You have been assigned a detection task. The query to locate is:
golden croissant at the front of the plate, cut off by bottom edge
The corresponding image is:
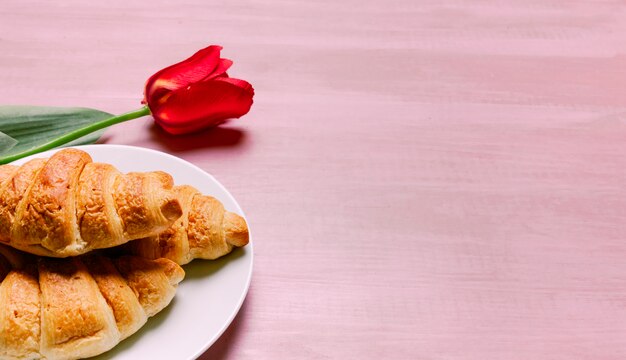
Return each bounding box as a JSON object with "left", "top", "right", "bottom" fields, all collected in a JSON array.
[{"left": 0, "top": 245, "right": 184, "bottom": 360}]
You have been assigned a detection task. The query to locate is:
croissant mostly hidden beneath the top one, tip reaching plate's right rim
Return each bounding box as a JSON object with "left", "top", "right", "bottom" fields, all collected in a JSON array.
[{"left": 124, "top": 185, "right": 249, "bottom": 265}]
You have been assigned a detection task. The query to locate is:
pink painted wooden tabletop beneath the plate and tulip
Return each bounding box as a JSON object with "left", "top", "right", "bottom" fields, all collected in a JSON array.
[{"left": 0, "top": 0, "right": 626, "bottom": 360}]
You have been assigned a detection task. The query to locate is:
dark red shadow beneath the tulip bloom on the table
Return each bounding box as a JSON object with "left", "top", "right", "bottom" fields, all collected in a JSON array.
[{"left": 150, "top": 124, "right": 246, "bottom": 152}]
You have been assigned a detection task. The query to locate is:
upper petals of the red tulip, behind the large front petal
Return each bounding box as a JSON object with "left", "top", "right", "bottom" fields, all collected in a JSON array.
[{"left": 144, "top": 45, "right": 232, "bottom": 105}]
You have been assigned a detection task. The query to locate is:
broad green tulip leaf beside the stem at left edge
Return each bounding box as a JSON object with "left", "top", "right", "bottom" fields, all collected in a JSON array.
[{"left": 0, "top": 106, "right": 113, "bottom": 163}]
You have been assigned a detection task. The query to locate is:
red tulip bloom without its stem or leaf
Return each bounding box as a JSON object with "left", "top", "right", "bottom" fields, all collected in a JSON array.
[{"left": 143, "top": 45, "right": 254, "bottom": 134}]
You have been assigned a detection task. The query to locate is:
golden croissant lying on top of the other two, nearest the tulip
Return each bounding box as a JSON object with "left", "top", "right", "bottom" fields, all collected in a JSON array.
[{"left": 0, "top": 149, "right": 182, "bottom": 257}]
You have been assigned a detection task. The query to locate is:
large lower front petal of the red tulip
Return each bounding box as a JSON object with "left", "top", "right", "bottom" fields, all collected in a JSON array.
[{"left": 152, "top": 77, "right": 254, "bottom": 135}]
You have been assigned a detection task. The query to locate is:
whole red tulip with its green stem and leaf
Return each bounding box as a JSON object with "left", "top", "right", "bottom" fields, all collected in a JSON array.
[{"left": 0, "top": 45, "right": 254, "bottom": 163}]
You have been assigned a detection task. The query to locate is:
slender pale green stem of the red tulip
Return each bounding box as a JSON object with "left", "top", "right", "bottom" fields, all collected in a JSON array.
[{"left": 0, "top": 106, "right": 150, "bottom": 164}]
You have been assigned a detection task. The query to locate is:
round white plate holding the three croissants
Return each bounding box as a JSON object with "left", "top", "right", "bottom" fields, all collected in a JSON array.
[{"left": 14, "top": 145, "right": 253, "bottom": 360}]
